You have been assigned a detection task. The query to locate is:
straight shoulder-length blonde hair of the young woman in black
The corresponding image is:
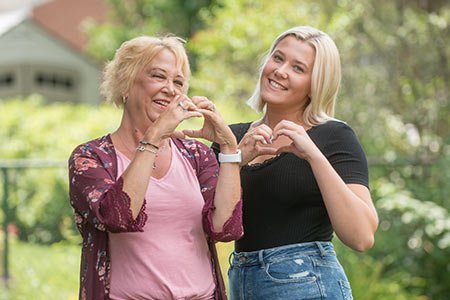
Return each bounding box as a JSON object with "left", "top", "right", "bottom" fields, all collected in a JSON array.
[{"left": 247, "top": 26, "right": 341, "bottom": 126}]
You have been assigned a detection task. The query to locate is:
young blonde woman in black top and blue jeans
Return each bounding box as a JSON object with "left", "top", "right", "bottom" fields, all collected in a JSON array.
[{"left": 213, "top": 26, "right": 378, "bottom": 300}]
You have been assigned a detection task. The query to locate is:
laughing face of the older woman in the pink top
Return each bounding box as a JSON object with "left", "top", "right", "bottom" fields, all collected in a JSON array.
[{"left": 126, "top": 49, "right": 186, "bottom": 126}]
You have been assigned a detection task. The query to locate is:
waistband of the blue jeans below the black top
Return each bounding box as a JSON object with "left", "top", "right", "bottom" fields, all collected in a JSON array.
[{"left": 229, "top": 242, "right": 336, "bottom": 266}]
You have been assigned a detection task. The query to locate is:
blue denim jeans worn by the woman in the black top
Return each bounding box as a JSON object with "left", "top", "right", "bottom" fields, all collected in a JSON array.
[{"left": 228, "top": 242, "right": 353, "bottom": 300}]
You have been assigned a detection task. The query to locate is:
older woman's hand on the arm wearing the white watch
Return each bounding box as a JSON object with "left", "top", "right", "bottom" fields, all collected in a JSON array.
[{"left": 183, "top": 96, "right": 237, "bottom": 149}]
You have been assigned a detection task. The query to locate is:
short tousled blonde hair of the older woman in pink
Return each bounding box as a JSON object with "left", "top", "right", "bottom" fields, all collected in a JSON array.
[{"left": 100, "top": 36, "right": 191, "bottom": 107}]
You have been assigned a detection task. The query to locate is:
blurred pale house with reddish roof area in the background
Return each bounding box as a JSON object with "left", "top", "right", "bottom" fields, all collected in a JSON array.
[{"left": 0, "top": 0, "right": 108, "bottom": 104}]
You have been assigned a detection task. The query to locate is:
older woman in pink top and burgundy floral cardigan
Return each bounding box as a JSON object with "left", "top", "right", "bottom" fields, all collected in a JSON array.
[{"left": 69, "top": 36, "right": 242, "bottom": 300}]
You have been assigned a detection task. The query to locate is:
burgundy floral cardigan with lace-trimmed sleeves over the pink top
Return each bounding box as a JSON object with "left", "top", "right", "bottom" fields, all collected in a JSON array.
[{"left": 69, "top": 135, "right": 243, "bottom": 300}]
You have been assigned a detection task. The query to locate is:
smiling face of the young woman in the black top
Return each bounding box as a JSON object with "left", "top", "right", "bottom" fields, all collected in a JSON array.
[{"left": 261, "top": 36, "right": 315, "bottom": 111}]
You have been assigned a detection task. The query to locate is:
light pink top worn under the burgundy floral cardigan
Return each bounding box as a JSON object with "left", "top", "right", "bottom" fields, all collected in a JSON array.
[{"left": 108, "top": 142, "right": 215, "bottom": 299}]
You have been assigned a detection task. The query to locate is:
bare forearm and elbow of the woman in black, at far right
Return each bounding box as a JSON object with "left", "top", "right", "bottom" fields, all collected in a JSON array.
[{"left": 308, "top": 153, "right": 378, "bottom": 251}]
